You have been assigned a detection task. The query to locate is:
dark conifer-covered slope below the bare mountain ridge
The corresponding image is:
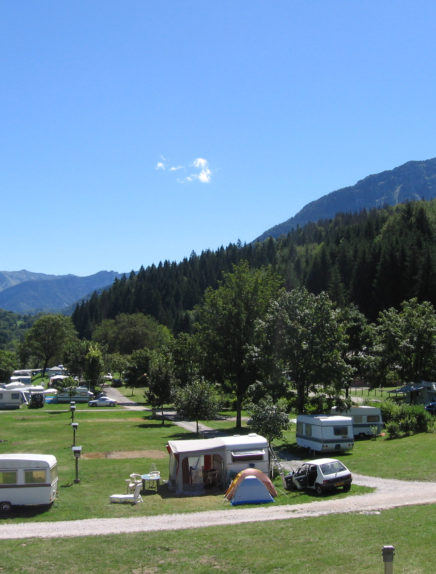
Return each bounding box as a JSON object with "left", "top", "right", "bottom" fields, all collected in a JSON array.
[{"left": 73, "top": 200, "right": 436, "bottom": 338}]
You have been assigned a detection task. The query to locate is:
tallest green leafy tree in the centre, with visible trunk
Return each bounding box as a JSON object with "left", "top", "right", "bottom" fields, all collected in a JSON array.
[{"left": 195, "top": 261, "right": 280, "bottom": 427}]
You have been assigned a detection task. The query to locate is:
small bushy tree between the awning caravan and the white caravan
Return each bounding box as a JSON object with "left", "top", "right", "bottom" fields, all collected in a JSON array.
[{"left": 248, "top": 396, "right": 289, "bottom": 444}]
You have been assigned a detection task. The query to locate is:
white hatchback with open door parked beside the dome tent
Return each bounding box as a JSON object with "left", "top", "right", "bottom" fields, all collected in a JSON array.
[{"left": 285, "top": 458, "right": 353, "bottom": 495}]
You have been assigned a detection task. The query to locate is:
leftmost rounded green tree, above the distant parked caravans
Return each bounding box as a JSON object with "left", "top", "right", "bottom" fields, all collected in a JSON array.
[{"left": 20, "top": 315, "right": 77, "bottom": 376}]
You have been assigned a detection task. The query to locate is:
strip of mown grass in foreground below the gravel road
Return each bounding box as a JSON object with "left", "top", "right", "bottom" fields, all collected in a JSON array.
[{"left": 0, "top": 506, "right": 436, "bottom": 574}]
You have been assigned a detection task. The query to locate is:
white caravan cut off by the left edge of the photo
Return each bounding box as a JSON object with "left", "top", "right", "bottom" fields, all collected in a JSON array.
[{"left": 0, "top": 454, "right": 58, "bottom": 512}]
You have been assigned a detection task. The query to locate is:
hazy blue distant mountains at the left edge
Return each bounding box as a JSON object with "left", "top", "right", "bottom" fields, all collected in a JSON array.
[{"left": 0, "top": 270, "right": 122, "bottom": 314}]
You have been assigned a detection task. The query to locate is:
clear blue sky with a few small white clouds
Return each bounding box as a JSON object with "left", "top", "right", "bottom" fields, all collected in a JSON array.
[{"left": 0, "top": 0, "right": 436, "bottom": 275}]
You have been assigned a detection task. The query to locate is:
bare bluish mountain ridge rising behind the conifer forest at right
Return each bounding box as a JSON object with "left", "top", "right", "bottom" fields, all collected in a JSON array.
[{"left": 255, "top": 158, "right": 436, "bottom": 241}]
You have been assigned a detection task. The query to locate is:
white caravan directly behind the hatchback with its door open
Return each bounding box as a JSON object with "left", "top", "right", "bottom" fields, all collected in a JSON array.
[{"left": 297, "top": 415, "right": 354, "bottom": 452}]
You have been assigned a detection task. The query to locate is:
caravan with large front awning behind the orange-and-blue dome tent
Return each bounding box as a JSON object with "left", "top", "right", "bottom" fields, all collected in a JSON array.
[{"left": 167, "top": 433, "right": 269, "bottom": 494}]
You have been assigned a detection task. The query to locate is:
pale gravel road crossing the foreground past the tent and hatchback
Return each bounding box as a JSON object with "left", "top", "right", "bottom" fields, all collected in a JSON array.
[{"left": 0, "top": 475, "right": 436, "bottom": 540}]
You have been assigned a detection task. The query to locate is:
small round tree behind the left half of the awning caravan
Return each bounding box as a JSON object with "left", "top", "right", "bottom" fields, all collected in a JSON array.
[{"left": 173, "top": 379, "right": 220, "bottom": 434}]
